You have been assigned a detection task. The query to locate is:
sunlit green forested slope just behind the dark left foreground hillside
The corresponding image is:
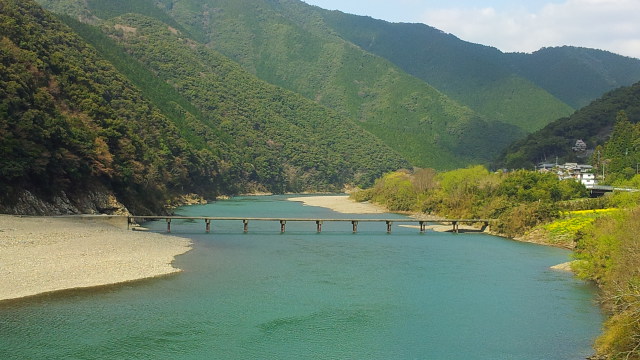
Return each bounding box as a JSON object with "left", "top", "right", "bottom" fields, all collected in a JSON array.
[{"left": 103, "top": 14, "right": 408, "bottom": 191}]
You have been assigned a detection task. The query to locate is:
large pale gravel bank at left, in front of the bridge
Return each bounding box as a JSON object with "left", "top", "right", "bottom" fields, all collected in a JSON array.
[{"left": 0, "top": 215, "right": 191, "bottom": 300}]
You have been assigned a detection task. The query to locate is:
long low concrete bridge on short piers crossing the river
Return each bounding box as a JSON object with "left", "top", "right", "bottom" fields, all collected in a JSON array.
[{"left": 127, "top": 216, "right": 495, "bottom": 234}]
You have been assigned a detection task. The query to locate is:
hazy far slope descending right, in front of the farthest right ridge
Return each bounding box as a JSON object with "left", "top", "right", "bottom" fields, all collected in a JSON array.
[{"left": 318, "top": 11, "right": 573, "bottom": 131}]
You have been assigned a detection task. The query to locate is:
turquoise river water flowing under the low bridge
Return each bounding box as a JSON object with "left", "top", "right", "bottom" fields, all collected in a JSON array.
[{"left": 0, "top": 196, "right": 602, "bottom": 360}]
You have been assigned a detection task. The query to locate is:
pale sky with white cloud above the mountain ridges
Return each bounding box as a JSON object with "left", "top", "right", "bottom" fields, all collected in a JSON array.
[{"left": 303, "top": 0, "right": 640, "bottom": 58}]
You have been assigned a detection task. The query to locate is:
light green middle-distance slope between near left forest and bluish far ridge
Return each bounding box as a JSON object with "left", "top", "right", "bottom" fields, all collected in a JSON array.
[{"left": 40, "top": 0, "right": 524, "bottom": 168}]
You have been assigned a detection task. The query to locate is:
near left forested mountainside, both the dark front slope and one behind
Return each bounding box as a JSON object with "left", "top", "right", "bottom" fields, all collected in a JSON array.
[{"left": 0, "top": 0, "right": 408, "bottom": 212}]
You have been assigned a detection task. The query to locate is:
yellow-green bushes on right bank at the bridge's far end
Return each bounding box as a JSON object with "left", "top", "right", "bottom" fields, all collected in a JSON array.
[{"left": 353, "top": 166, "right": 588, "bottom": 237}]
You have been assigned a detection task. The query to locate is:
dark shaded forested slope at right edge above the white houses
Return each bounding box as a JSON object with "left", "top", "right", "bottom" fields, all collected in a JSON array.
[{"left": 497, "top": 82, "right": 640, "bottom": 168}]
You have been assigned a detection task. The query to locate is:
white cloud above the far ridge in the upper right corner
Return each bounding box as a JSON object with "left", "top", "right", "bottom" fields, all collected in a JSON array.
[{"left": 422, "top": 0, "right": 640, "bottom": 58}]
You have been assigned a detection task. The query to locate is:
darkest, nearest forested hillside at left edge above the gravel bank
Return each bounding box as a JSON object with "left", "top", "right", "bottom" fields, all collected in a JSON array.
[{"left": 0, "top": 0, "right": 228, "bottom": 211}]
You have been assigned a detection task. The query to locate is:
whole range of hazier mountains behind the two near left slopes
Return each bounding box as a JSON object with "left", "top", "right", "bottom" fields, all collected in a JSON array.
[{"left": 33, "top": 0, "right": 640, "bottom": 169}]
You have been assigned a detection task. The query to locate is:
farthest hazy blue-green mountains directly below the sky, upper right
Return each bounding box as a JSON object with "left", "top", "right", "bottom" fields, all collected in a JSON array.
[{"left": 322, "top": 11, "right": 640, "bottom": 126}]
